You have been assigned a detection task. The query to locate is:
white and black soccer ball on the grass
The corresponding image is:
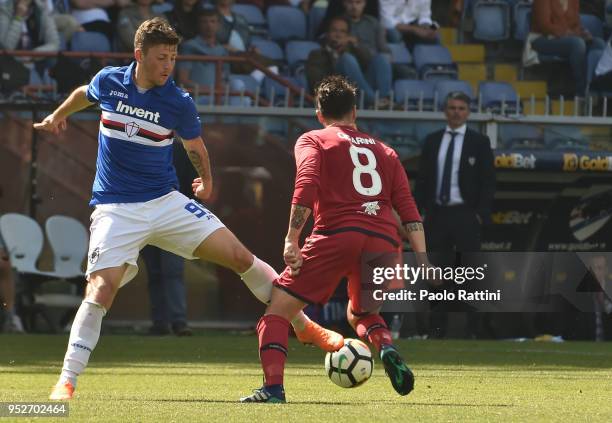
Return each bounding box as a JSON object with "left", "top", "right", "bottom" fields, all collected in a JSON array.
[{"left": 325, "top": 339, "right": 374, "bottom": 388}]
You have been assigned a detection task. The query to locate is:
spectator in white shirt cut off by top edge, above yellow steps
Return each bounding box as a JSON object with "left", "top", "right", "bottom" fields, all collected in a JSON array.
[{"left": 380, "top": 0, "right": 438, "bottom": 49}]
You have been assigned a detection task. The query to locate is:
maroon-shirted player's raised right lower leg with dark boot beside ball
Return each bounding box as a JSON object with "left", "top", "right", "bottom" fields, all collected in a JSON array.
[{"left": 347, "top": 302, "right": 414, "bottom": 395}]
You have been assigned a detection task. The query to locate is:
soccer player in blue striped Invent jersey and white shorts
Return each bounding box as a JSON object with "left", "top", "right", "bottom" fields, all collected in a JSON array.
[{"left": 34, "top": 18, "right": 344, "bottom": 400}]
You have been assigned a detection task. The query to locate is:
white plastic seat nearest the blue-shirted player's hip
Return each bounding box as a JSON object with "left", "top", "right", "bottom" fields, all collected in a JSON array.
[{"left": 45, "top": 215, "right": 88, "bottom": 278}]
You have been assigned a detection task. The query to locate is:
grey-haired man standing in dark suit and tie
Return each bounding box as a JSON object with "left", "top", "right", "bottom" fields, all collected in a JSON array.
[{"left": 414, "top": 92, "right": 495, "bottom": 337}]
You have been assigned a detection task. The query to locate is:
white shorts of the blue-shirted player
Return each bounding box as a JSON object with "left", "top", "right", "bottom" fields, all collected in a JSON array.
[{"left": 86, "top": 191, "right": 225, "bottom": 286}]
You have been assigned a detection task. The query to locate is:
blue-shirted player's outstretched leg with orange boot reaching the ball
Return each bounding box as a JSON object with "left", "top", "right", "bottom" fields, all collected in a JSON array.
[{"left": 194, "top": 228, "right": 344, "bottom": 352}]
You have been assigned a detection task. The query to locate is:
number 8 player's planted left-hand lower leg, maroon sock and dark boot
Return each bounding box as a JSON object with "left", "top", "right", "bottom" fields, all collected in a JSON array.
[{"left": 240, "top": 289, "right": 306, "bottom": 404}]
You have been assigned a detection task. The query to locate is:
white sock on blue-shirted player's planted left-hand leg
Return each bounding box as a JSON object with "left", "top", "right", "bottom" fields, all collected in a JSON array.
[{"left": 60, "top": 300, "right": 106, "bottom": 386}]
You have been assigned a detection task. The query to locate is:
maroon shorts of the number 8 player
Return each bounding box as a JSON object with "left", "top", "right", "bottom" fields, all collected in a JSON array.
[{"left": 274, "top": 231, "right": 401, "bottom": 314}]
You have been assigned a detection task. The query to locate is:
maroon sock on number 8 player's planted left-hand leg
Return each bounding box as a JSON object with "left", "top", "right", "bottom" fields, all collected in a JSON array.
[{"left": 257, "top": 314, "right": 289, "bottom": 386}]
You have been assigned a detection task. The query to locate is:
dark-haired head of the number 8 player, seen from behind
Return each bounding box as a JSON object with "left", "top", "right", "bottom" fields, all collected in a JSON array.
[{"left": 315, "top": 75, "right": 357, "bottom": 119}]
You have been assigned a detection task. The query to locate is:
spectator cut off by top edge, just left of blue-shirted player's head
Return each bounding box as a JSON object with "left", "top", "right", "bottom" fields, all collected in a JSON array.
[{"left": 70, "top": 0, "right": 132, "bottom": 42}]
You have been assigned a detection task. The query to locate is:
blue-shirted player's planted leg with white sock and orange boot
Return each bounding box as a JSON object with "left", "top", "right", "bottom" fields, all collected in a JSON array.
[{"left": 49, "top": 266, "right": 125, "bottom": 401}]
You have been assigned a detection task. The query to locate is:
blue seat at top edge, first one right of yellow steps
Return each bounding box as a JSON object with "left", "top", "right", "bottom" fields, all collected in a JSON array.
[{"left": 472, "top": 0, "right": 510, "bottom": 41}]
